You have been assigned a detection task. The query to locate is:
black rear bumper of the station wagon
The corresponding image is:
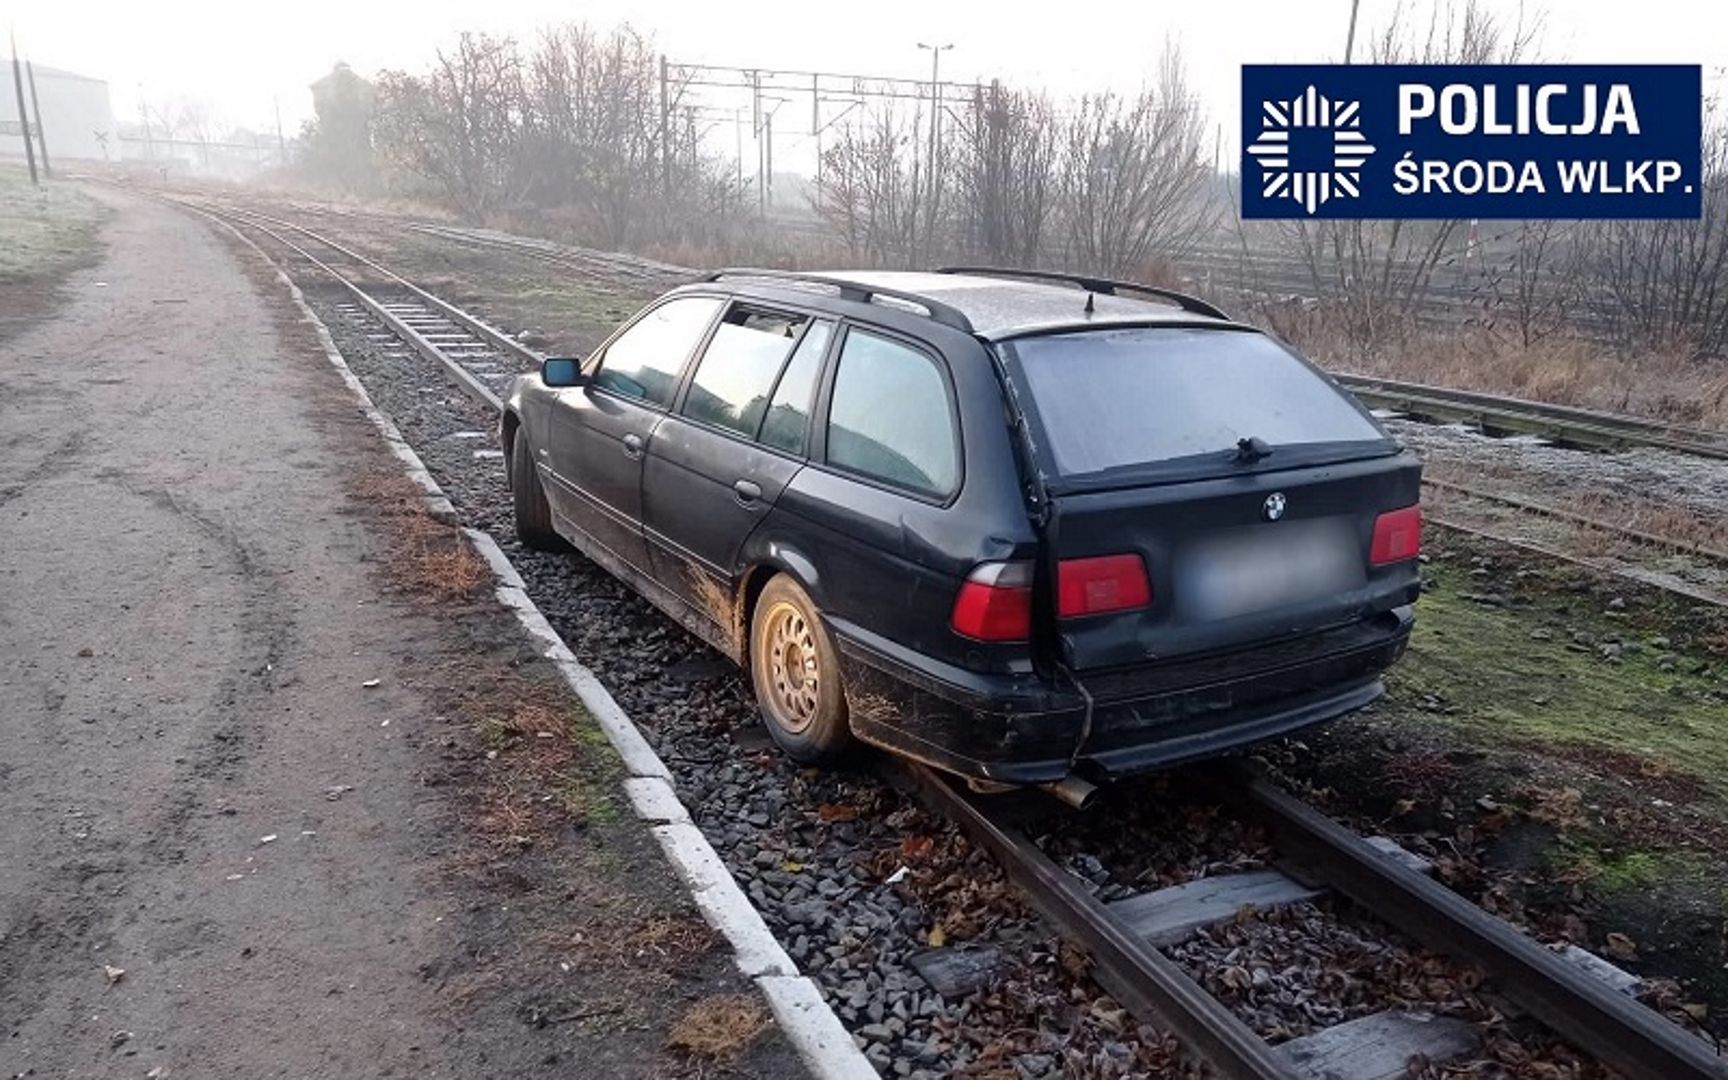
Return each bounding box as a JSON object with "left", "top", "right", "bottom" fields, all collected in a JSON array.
[{"left": 833, "top": 607, "right": 1414, "bottom": 785}]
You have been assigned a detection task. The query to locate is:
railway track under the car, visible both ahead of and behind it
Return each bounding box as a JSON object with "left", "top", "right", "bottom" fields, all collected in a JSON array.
[{"left": 178, "top": 200, "right": 1728, "bottom": 1080}]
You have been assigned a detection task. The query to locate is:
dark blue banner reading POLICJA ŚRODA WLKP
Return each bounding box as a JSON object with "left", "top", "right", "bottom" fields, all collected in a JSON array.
[{"left": 1242, "top": 64, "right": 1704, "bottom": 219}]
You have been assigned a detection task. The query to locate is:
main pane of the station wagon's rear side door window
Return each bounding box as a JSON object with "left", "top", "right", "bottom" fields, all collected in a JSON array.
[{"left": 683, "top": 304, "right": 810, "bottom": 439}]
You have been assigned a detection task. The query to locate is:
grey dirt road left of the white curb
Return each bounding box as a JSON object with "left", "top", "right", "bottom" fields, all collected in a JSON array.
[{"left": 0, "top": 194, "right": 791, "bottom": 1077}]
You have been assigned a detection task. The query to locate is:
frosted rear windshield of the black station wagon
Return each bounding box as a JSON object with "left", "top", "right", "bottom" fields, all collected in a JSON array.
[{"left": 1002, "top": 327, "right": 1386, "bottom": 477}]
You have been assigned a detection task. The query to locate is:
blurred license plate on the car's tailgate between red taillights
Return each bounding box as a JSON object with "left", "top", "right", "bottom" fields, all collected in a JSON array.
[{"left": 1175, "top": 518, "right": 1365, "bottom": 620}]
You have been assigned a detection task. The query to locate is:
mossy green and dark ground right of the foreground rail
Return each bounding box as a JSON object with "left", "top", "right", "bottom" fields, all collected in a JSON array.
[{"left": 1263, "top": 532, "right": 1728, "bottom": 1033}]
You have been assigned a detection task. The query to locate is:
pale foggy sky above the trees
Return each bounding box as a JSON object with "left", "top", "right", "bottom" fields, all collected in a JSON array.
[{"left": 0, "top": 0, "right": 1728, "bottom": 164}]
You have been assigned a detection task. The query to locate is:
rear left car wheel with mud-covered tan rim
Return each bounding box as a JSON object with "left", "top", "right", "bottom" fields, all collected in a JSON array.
[{"left": 750, "top": 574, "right": 854, "bottom": 766}]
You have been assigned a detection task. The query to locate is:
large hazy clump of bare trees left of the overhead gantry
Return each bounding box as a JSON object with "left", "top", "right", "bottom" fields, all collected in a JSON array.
[{"left": 373, "top": 26, "right": 740, "bottom": 247}]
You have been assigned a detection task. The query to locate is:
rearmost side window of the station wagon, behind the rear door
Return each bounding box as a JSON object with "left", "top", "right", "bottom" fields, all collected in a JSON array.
[{"left": 828, "top": 328, "right": 959, "bottom": 496}]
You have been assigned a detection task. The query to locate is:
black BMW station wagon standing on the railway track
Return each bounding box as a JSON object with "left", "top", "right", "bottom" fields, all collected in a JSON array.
[{"left": 499, "top": 270, "right": 1420, "bottom": 800}]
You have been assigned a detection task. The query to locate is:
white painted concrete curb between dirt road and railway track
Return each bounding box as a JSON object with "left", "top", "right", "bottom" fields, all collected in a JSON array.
[{"left": 199, "top": 211, "right": 878, "bottom": 1080}]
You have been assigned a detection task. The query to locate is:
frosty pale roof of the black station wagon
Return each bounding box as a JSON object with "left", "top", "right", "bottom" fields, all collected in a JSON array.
[{"left": 701, "top": 270, "right": 1237, "bottom": 340}]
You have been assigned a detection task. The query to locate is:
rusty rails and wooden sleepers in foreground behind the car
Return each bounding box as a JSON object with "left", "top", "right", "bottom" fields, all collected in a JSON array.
[{"left": 907, "top": 762, "right": 1728, "bottom": 1080}]
